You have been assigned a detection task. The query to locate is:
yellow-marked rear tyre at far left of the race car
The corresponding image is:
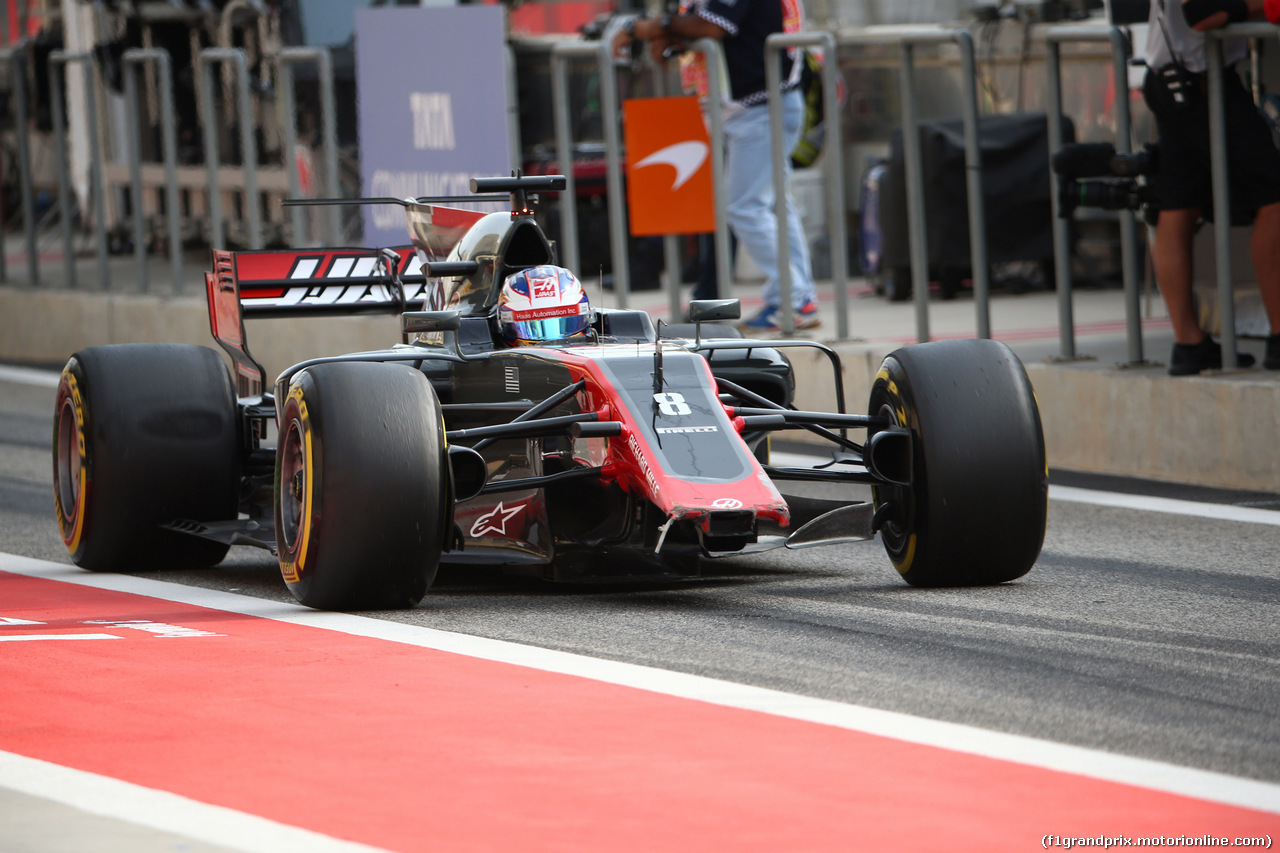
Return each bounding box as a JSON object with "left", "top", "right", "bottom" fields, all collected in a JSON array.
[{"left": 54, "top": 343, "right": 239, "bottom": 571}]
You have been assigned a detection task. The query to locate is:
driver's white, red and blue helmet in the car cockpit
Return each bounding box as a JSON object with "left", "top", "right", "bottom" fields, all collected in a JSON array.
[{"left": 498, "top": 264, "right": 591, "bottom": 347}]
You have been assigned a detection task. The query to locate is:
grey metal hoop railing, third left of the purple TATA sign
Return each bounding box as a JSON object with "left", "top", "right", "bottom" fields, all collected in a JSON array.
[{"left": 123, "top": 47, "right": 182, "bottom": 293}]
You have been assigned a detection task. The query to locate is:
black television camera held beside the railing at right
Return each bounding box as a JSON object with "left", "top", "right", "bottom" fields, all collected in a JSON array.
[{"left": 1053, "top": 142, "right": 1160, "bottom": 219}]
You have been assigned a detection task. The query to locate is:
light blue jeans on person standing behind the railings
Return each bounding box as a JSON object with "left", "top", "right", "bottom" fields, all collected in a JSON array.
[{"left": 724, "top": 88, "right": 814, "bottom": 309}]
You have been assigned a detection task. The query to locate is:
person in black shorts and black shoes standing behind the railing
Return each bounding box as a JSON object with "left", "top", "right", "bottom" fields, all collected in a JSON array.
[{"left": 1143, "top": 0, "right": 1280, "bottom": 377}]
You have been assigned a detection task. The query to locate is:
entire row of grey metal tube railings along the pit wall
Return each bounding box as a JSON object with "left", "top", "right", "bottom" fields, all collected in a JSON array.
[{"left": 0, "top": 20, "right": 1239, "bottom": 365}]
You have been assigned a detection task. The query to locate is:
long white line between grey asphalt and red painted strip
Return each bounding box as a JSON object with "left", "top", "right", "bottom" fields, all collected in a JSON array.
[{"left": 0, "top": 553, "right": 1280, "bottom": 819}]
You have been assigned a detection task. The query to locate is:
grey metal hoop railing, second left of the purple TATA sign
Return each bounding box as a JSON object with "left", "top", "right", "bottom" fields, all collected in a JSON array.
[{"left": 200, "top": 47, "right": 262, "bottom": 248}]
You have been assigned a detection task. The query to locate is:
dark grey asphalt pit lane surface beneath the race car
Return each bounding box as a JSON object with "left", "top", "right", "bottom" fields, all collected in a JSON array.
[{"left": 0, "top": 374, "right": 1280, "bottom": 781}]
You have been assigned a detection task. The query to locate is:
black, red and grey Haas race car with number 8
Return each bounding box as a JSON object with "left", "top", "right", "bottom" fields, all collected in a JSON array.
[{"left": 54, "top": 175, "right": 1048, "bottom": 610}]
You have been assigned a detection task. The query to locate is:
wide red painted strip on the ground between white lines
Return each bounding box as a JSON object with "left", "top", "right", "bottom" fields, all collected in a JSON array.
[{"left": 0, "top": 573, "right": 1276, "bottom": 852}]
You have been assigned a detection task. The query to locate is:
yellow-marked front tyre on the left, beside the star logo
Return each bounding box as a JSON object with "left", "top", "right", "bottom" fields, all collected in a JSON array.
[{"left": 275, "top": 362, "right": 452, "bottom": 610}]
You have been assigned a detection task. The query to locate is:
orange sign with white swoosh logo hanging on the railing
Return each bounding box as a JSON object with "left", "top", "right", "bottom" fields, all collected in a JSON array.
[{"left": 622, "top": 97, "right": 716, "bottom": 237}]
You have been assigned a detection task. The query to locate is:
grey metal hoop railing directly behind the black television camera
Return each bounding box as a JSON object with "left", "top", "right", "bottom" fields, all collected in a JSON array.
[{"left": 1044, "top": 27, "right": 1146, "bottom": 366}]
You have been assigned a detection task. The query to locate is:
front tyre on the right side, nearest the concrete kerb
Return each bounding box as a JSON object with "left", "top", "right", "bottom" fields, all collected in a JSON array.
[{"left": 869, "top": 341, "right": 1048, "bottom": 587}]
